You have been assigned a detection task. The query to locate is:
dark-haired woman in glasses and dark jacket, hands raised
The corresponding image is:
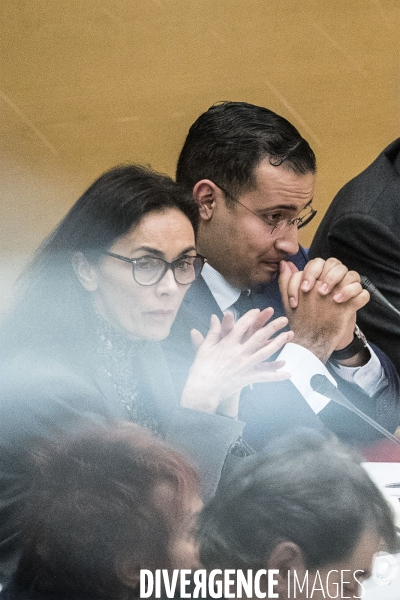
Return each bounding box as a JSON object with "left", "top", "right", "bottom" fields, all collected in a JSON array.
[{"left": 0, "top": 166, "right": 292, "bottom": 582}]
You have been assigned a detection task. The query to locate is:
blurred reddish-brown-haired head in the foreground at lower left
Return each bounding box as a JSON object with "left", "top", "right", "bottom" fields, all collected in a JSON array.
[{"left": 14, "top": 424, "right": 201, "bottom": 600}]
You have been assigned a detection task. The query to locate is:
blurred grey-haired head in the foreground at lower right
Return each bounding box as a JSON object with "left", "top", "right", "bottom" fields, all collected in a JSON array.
[{"left": 199, "top": 431, "right": 396, "bottom": 600}]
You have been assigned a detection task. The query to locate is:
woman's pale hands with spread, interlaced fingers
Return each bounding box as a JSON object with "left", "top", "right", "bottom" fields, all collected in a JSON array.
[{"left": 181, "top": 308, "right": 293, "bottom": 417}]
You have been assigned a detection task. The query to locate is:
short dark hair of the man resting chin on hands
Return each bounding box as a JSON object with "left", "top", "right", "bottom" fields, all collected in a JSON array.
[{"left": 176, "top": 102, "right": 316, "bottom": 200}]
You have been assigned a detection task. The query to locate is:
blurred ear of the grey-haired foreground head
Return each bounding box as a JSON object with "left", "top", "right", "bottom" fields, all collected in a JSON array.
[{"left": 266, "top": 542, "right": 306, "bottom": 599}]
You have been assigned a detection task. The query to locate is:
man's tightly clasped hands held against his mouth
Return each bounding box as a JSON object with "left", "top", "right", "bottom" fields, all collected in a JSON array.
[{"left": 279, "top": 259, "right": 369, "bottom": 366}]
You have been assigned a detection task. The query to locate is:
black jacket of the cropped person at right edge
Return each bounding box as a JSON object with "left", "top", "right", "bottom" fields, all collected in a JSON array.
[{"left": 310, "top": 138, "right": 400, "bottom": 373}]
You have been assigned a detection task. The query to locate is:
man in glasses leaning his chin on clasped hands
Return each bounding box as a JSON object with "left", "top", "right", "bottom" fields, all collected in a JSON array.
[{"left": 166, "top": 102, "right": 399, "bottom": 448}]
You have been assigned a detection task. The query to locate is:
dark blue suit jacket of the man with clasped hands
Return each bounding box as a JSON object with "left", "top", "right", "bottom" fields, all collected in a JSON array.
[{"left": 163, "top": 249, "right": 400, "bottom": 449}]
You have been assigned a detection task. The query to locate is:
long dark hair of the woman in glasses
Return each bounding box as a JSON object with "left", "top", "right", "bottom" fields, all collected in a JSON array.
[{"left": 0, "top": 165, "right": 198, "bottom": 357}]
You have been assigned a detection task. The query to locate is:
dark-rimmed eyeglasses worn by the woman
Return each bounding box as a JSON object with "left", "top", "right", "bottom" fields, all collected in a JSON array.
[{"left": 104, "top": 252, "right": 205, "bottom": 285}]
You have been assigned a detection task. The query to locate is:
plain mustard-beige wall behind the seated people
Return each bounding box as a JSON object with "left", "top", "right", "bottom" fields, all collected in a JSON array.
[{"left": 0, "top": 0, "right": 400, "bottom": 308}]
